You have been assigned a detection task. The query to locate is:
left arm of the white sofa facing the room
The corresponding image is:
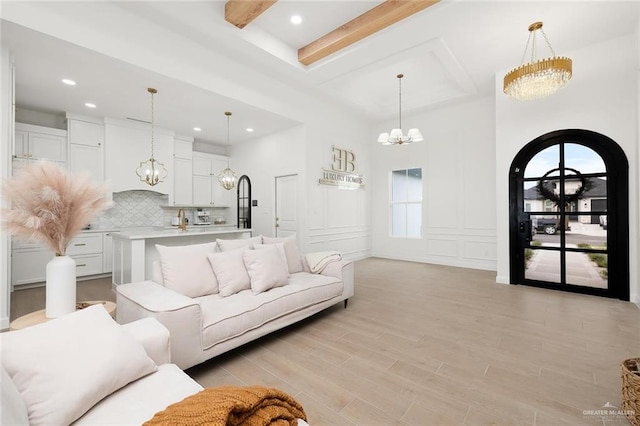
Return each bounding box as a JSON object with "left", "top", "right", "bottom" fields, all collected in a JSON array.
[{"left": 116, "top": 281, "right": 203, "bottom": 369}]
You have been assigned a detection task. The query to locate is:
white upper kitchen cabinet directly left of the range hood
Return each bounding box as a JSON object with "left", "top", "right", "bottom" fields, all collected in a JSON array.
[{"left": 67, "top": 114, "right": 104, "bottom": 182}]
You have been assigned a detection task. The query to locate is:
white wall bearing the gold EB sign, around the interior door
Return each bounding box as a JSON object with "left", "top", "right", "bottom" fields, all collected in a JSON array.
[{"left": 230, "top": 115, "right": 371, "bottom": 259}]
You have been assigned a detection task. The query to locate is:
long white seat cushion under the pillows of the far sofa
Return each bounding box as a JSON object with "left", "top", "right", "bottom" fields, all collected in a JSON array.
[{"left": 197, "top": 272, "right": 344, "bottom": 350}]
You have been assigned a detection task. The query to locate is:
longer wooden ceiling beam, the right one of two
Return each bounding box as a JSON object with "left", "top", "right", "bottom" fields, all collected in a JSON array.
[{"left": 298, "top": 0, "right": 440, "bottom": 65}]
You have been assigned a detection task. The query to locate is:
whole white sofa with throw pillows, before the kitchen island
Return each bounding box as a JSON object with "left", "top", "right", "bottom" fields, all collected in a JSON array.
[{"left": 116, "top": 237, "right": 354, "bottom": 369}]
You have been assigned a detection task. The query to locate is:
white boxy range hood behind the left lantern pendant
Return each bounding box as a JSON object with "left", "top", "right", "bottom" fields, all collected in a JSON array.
[{"left": 104, "top": 119, "right": 175, "bottom": 198}]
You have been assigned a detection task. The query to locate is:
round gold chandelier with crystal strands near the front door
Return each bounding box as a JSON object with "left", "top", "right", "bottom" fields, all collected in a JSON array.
[{"left": 503, "top": 22, "right": 573, "bottom": 100}]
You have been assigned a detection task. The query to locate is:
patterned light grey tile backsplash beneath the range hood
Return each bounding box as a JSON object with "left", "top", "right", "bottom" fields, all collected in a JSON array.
[{"left": 92, "top": 190, "right": 168, "bottom": 228}]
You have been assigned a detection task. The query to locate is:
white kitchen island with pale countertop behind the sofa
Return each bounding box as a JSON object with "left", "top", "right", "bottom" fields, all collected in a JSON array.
[{"left": 111, "top": 226, "right": 251, "bottom": 285}]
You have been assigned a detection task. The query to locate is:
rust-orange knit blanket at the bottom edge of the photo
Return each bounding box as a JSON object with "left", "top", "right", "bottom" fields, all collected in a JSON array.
[{"left": 144, "top": 386, "right": 307, "bottom": 426}]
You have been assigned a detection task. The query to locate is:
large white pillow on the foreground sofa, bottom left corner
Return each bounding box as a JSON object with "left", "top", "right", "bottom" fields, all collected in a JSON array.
[{"left": 0, "top": 305, "right": 156, "bottom": 425}]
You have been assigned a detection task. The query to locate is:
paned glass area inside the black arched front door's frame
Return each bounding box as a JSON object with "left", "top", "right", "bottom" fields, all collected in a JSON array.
[{"left": 520, "top": 142, "right": 608, "bottom": 289}]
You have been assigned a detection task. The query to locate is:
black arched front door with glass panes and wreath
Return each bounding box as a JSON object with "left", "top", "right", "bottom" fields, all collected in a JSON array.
[{"left": 509, "top": 129, "right": 629, "bottom": 300}]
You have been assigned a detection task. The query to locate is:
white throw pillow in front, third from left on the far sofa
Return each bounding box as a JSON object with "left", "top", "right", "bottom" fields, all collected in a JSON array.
[{"left": 242, "top": 244, "right": 289, "bottom": 294}]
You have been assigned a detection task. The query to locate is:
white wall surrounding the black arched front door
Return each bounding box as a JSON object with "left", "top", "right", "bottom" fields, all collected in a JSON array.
[{"left": 495, "top": 35, "right": 640, "bottom": 300}]
